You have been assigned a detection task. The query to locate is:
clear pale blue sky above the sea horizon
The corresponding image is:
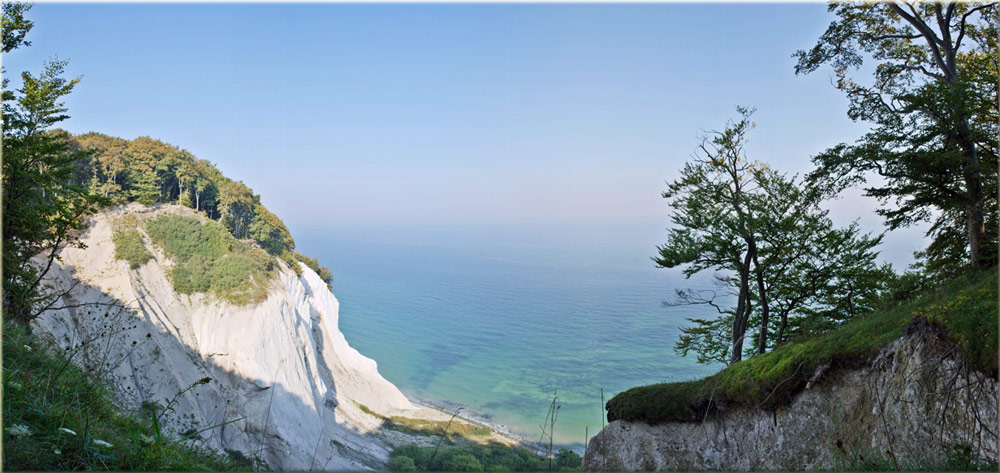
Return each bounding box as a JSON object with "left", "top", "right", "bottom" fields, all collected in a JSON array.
[{"left": 3, "top": 3, "right": 924, "bottom": 258}]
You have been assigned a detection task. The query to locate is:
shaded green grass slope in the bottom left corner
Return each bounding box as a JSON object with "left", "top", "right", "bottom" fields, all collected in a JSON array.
[{"left": 3, "top": 321, "right": 254, "bottom": 471}]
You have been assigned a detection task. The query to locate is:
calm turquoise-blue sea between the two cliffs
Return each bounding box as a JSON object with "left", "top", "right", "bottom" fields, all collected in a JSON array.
[{"left": 293, "top": 225, "right": 718, "bottom": 445}]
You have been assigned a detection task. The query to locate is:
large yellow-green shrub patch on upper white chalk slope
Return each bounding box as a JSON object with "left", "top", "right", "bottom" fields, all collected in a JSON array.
[{"left": 146, "top": 215, "right": 274, "bottom": 305}]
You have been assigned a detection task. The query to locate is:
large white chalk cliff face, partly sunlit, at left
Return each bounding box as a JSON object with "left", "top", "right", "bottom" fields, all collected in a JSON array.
[{"left": 36, "top": 204, "right": 434, "bottom": 470}]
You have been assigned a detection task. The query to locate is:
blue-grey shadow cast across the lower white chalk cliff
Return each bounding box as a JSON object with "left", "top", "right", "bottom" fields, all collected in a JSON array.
[{"left": 34, "top": 266, "right": 402, "bottom": 470}]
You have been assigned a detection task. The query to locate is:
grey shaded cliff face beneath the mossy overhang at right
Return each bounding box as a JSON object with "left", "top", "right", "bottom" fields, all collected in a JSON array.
[{"left": 583, "top": 321, "right": 998, "bottom": 471}]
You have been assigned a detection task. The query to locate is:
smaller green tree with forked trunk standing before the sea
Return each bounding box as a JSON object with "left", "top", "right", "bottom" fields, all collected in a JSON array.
[{"left": 654, "top": 109, "right": 892, "bottom": 363}]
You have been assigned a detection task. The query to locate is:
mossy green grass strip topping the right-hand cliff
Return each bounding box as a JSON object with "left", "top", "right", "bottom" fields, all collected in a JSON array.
[{"left": 607, "top": 269, "right": 998, "bottom": 423}]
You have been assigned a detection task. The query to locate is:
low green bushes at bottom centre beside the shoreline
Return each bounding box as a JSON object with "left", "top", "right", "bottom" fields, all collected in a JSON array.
[{"left": 389, "top": 443, "right": 583, "bottom": 471}]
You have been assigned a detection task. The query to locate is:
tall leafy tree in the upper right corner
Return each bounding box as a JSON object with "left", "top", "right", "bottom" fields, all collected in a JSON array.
[{"left": 795, "top": 2, "right": 998, "bottom": 267}]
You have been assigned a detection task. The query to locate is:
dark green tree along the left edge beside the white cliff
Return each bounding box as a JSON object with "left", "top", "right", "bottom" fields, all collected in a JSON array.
[{"left": 2, "top": 19, "right": 104, "bottom": 322}]
